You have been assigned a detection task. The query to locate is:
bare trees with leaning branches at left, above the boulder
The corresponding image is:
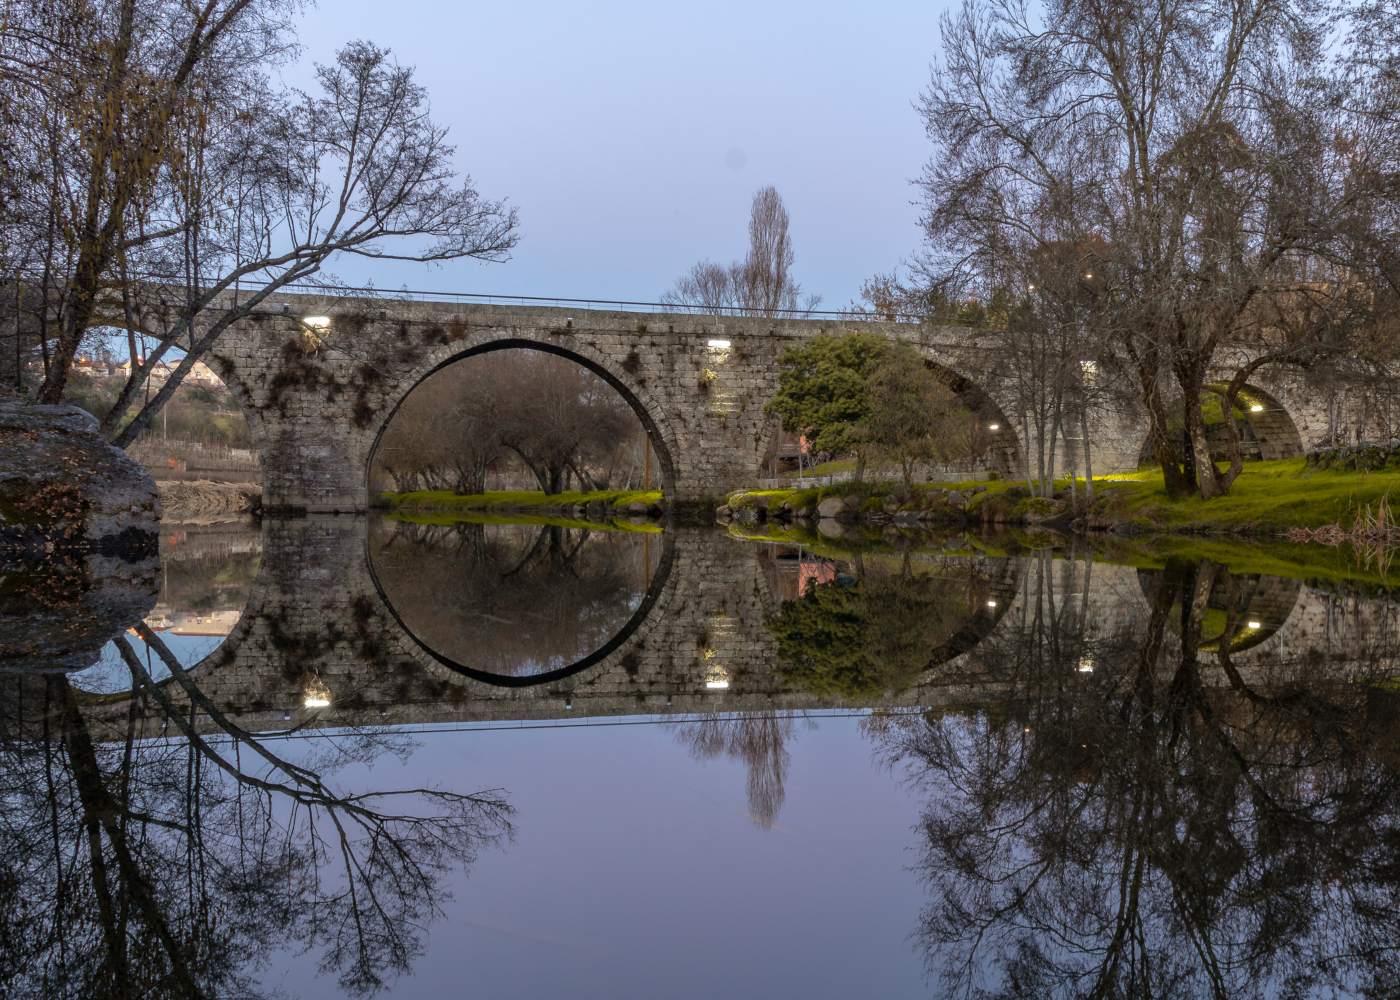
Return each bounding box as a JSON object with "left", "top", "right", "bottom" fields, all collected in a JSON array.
[{"left": 0, "top": 0, "right": 517, "bottom": 444}]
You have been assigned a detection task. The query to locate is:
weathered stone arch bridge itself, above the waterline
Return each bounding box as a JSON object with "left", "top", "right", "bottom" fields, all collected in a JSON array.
[{"left": 117, "top": 294, "right": 1377, "bottom": 511}]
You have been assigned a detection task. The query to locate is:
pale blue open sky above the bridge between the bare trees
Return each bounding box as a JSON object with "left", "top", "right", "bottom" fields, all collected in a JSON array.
[{"left": 289, "top": 0, "right": 948, "bottom": 308}]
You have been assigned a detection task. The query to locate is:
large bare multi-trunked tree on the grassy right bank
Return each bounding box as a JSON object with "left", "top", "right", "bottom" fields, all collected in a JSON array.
[{"left": 920, "top": 0, "right": 1397, "bottom": 496}]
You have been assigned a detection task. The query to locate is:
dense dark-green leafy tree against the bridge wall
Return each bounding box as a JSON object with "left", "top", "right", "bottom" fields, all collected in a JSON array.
[{"left": 766, "top": 333, "right": 889, "bottom": 479}]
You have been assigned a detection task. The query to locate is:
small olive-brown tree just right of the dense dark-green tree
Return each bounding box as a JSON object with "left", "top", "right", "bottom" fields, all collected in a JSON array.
[{"left": 864, "top": 343, "right": 973, "bottom": 490}]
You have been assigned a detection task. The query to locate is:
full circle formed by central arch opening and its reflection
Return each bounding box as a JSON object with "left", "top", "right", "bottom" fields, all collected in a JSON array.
[{"left": 367, "top": 339, "right": 675, "bottom": 686}]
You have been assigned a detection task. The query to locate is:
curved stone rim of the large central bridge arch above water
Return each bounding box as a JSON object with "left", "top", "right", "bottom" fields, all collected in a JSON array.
[{"left": 364, "top": 331, "right": 679, "bottom": 496}]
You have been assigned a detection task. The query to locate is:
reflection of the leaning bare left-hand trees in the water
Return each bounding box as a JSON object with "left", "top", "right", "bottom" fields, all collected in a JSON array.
[{"left": 0, "top": 627, "right": 510, "bottom": 997}]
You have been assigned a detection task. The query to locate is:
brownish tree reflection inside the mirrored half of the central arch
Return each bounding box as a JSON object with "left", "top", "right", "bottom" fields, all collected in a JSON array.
[{"left": 374, "top": 522, "right": 659, "bottom": 675}]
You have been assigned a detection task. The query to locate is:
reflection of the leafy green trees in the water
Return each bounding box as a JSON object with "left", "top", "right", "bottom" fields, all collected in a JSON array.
[{"left": 767, "top": 553, "right": 991, "bottom": 700}]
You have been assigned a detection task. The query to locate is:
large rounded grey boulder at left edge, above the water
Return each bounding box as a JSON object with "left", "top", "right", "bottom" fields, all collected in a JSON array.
[{"left": 0, "top": 395, "right": 161, "bottom": 555}]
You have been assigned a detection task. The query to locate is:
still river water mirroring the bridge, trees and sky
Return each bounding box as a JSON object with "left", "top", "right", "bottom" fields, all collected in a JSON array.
[{"left": 0, "top": 518, "right": 1400, "bottom": 997}]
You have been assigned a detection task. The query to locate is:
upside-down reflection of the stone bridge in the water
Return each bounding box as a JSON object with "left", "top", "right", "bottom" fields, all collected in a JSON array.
[{"left": 79, "top": 517, "right": 1400, "bottom": 730}]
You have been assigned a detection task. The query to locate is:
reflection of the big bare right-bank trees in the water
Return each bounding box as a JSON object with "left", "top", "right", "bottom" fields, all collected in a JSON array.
[{"left": 869, "top": 563, "right": 1400, "bottom": 997}]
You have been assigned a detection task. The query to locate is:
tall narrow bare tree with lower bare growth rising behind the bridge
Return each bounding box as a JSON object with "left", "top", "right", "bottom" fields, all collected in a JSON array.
[{"left": 661, "top": 185, "right": 820, "bottom": 317}]
